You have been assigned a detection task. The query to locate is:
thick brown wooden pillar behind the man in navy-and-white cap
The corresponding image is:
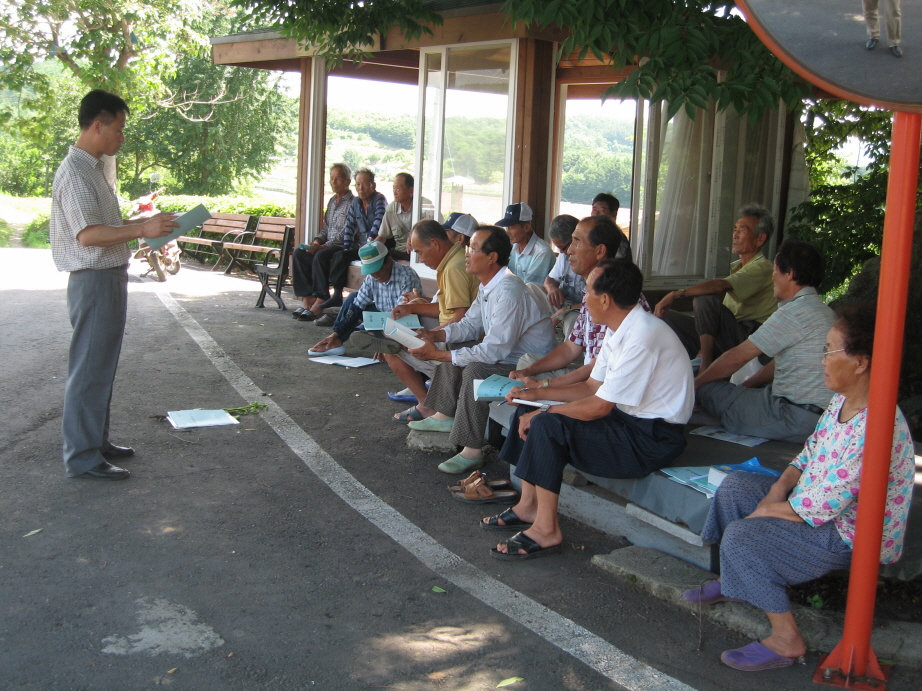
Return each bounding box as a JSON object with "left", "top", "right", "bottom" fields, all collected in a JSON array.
[{"left": 511, "top": 38, "right": 556, "bottom": 237}]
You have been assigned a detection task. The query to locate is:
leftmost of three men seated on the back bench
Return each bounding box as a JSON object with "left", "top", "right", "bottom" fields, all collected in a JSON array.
[{"left": 291, "top": 163, "right": 355, "bottom": 320}]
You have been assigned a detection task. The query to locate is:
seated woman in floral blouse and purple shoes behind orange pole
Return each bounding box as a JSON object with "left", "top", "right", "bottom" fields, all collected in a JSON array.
[{"left": 683, "top": 303, "right": 915, "bottom": 672}]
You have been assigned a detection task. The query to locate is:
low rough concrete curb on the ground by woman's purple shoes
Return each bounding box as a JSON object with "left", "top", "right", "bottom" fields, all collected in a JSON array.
[{"left": 592, "top": 546, "right": 922, "bottom": 669}]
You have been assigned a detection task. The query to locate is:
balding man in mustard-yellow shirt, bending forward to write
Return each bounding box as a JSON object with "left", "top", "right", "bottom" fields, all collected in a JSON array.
[{"left": 355, "top": 220, "right": 480, "bottom": 422}]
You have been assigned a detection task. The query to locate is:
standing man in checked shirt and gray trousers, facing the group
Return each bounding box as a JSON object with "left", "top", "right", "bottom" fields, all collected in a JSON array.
[{"left": 51, "top": 89, "right": 177, "bottom": 480}]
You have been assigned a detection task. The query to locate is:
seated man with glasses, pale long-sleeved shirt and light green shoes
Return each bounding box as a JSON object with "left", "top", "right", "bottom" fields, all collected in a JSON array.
[{"left": 410, "top": 226, "right": 554, "bottom": 473}]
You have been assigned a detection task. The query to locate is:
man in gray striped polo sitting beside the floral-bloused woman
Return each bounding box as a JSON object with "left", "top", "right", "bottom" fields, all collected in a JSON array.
[{"left": 695, "top": 240, "right": 834, "bottom": 444}]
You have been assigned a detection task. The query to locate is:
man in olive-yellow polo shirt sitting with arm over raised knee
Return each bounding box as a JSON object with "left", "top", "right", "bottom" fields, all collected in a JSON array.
[{"left": 654, "top": 204, "right": 778, "bottom": 372}]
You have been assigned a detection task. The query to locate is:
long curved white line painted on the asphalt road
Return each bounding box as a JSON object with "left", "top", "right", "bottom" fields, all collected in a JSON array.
[{"left": 155, "top": 286, "right": 695, "bottom": 691}]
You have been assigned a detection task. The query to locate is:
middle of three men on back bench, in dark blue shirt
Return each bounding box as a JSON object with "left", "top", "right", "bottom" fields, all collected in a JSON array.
[{"left": 298, "top": 168, "right": 387, "bottom": 321}]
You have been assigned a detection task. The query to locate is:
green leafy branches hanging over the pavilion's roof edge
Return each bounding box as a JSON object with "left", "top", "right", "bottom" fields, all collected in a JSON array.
[{"left": 241, "top": 0, "right": 809, "bottom": 121}]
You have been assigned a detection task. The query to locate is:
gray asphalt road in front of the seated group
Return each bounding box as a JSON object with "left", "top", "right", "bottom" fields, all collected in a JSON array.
[{"left": 0, "top": 249, "right": 922, "bottom": 691}]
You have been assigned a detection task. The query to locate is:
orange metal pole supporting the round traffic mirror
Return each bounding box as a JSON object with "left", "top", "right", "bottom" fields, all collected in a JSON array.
[{"left": 820, "top": 113, "right": 922, "bottom": 687}]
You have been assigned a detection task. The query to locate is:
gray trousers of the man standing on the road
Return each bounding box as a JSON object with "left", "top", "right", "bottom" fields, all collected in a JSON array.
[{"left": 61, "top": 266, "right": 128, "bottom": 477}]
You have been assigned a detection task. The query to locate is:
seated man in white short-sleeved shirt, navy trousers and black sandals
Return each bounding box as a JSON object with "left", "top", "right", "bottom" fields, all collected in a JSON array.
[{"left": 481, "top": 261, "right": 694, "bottom": 560}]
